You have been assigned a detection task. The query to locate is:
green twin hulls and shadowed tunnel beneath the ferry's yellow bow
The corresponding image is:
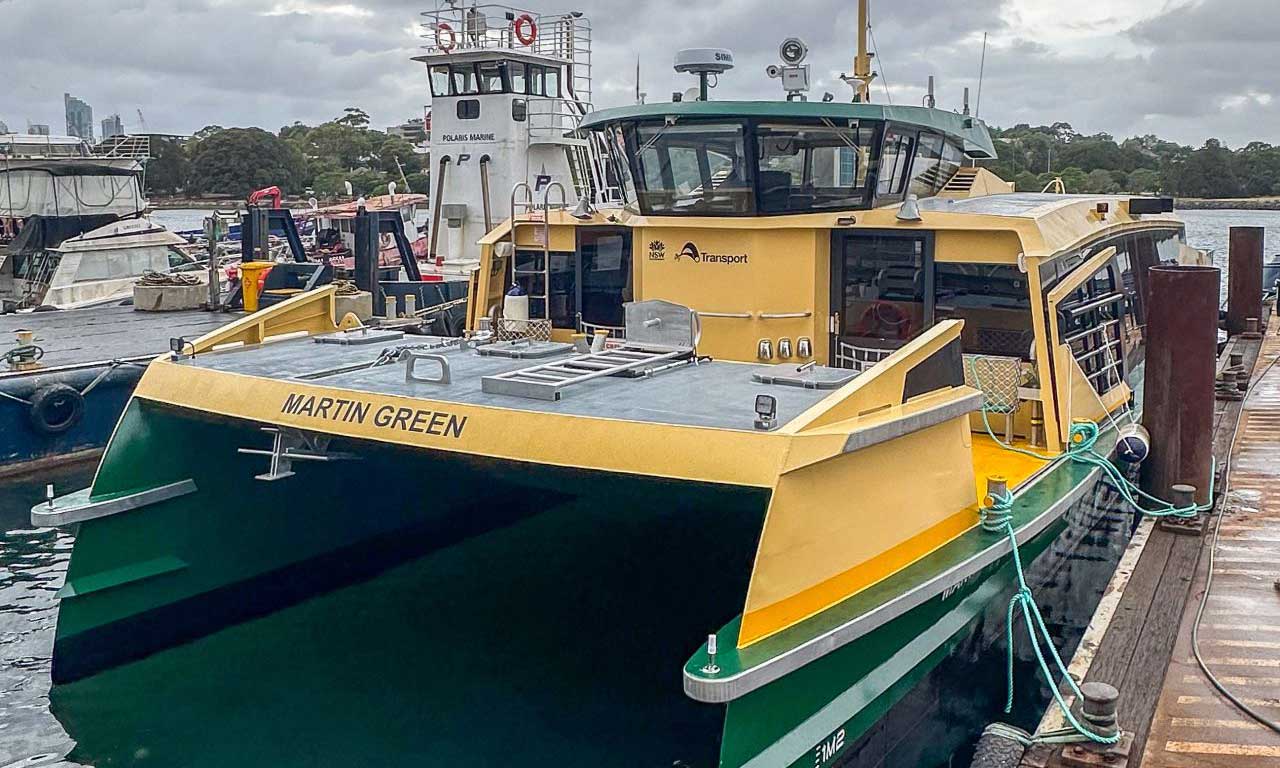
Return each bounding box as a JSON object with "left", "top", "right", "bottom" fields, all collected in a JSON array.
[{"left": 54, "top": 399, "right": 1121, "bottom": 768}]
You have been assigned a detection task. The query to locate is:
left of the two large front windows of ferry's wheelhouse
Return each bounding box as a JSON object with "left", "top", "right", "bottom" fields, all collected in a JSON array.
[{"left": 636, "top": 123, "right": 755, "bottom": 215}]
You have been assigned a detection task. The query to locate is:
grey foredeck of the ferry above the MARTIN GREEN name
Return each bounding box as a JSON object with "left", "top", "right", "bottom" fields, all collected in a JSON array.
[{"left": 182, "top": 337, "right": 831, "bottom": 430}]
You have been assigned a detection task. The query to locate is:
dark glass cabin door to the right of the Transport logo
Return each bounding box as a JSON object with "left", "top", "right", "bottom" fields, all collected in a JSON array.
[{"left": 831, "top": 230, "right": 933, "bottom": 371}]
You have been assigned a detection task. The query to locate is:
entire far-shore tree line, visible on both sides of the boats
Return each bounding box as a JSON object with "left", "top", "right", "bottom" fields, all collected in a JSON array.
[{"left": 147, "top": 108, "right": 1280, "bottom": 197}]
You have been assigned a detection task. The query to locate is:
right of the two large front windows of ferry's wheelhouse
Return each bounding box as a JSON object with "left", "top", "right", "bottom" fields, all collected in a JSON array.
[{"left": 755, "top": 123, "right": 874, "bottom": 214}]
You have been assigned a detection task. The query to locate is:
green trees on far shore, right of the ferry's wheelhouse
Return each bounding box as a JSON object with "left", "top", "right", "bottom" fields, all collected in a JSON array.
[{"left": 983, "top": 123, "right": 1280, "bottom": 197}]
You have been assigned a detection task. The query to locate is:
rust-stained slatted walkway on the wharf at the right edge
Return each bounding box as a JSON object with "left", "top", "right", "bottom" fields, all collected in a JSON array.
[{"left": 1130, "top": 316, "right": 1280, "bottom": 768}]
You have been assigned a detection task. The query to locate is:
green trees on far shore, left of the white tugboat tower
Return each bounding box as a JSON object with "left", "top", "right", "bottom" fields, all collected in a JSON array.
[{"left": 146, "top": 108, "right": 429, "bottom": 198}]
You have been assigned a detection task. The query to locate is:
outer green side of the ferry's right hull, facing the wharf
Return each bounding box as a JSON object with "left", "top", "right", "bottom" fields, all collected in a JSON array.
[{"left": 719, "top": 468, "right": 1129, "bottom": 768}]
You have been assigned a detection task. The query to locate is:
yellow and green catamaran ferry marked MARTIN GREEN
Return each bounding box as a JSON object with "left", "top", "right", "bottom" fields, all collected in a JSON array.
[{"left": 32, "top": 10, "right": 1203, "bottom": 768}]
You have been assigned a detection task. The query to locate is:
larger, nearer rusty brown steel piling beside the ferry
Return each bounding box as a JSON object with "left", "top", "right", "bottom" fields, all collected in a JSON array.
[{"left": 1142, "top": 266, "right": 1213, "bottom": 504}]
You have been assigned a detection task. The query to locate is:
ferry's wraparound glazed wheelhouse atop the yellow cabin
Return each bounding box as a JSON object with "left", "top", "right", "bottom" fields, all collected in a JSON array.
[{"left": 584, "top": 102, "right": 995, "bottom": 216}]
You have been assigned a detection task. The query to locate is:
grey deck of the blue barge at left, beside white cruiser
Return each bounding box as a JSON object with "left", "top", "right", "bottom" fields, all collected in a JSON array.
[{"left": 0, "top": 306, "right": 236, "bottom": 375}]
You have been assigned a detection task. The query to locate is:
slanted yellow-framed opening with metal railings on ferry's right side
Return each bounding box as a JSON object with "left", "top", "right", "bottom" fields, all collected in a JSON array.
[{"left": 1046, "top": 247, "right": 1133, "bottom": 444}]
